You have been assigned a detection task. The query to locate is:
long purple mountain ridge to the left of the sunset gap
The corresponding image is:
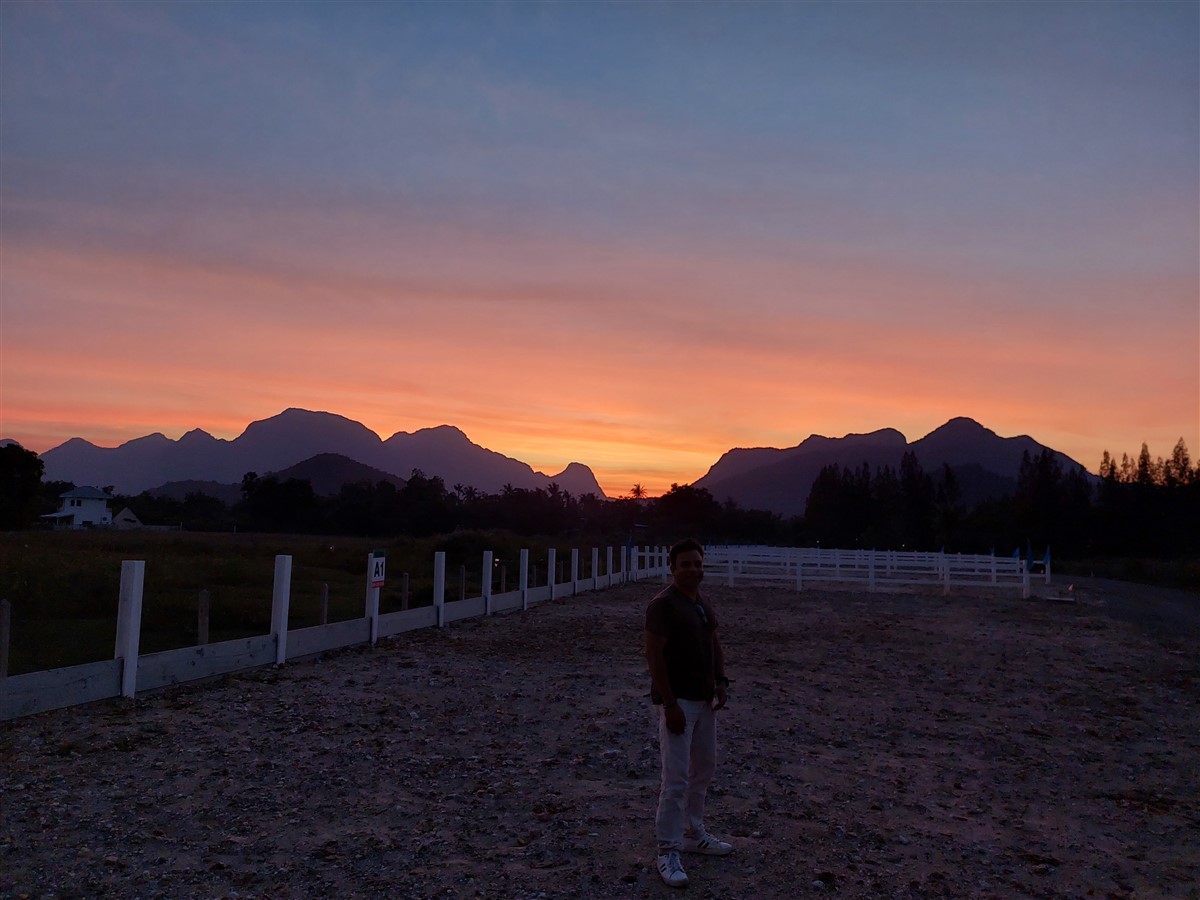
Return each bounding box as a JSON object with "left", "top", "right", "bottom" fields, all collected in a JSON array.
[{"left": 42, "top": 409, "right": 604, "bottom": 497}]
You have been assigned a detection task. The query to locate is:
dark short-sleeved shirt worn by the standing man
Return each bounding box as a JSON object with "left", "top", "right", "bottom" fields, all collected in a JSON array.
[{"left": 646, "top": 584, "right": 716, "bottom": 703}]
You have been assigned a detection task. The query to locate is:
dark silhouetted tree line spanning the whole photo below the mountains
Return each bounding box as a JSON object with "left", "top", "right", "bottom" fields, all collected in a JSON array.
[{"left": 0, "top": 439, "right": 1200, "bottom": 558}]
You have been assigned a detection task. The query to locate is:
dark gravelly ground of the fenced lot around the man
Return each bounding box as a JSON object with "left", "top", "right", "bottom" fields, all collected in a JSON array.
[{"left": 0, "top": 582, "right": 1200, "bottom": 900}]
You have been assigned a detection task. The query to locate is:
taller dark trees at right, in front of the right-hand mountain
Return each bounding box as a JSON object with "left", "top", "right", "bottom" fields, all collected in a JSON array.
[{"left": 802, "top": 440, "right": 1200, "bottom": 559}]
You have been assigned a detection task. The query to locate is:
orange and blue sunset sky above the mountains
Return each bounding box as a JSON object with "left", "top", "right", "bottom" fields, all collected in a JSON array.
[{"left": 0, "top": 0, "right": 1200, "bottom": 496}]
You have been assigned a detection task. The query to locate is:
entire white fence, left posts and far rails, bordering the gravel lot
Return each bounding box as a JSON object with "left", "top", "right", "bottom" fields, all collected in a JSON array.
[{"left": 0, "top": 546, "right": 1050, "bottom": 720}]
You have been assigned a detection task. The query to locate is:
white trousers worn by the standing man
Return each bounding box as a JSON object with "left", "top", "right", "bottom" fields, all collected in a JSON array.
[{"left": 654, "top": 700, "right": 716, "bottom": 851}]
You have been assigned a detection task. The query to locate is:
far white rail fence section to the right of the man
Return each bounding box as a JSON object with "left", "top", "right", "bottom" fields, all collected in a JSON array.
[{"left": 704, "top": 547, "right": 1050, "bottom": 598}]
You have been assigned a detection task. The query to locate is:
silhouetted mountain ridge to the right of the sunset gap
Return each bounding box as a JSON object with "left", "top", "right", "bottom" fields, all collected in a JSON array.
[{"left": 695, "top": 418, "right": 1094, "bottom": 516}]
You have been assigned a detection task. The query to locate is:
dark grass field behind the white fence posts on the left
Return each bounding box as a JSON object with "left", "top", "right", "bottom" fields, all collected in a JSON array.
[{"left": 0, "top": 532, "right": 580, "bottom": 674}]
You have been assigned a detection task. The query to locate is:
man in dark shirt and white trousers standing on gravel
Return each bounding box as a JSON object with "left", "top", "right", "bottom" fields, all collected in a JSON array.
[{"left": 646, "top": 539, "right": 733, "bottom": 888}]
